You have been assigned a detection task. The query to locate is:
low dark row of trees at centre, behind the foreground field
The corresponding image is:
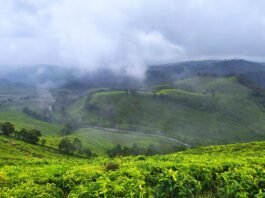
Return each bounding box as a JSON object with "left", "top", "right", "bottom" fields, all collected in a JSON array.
[{"left": 107, "top": 143, "right": 186, "bottom": 157}]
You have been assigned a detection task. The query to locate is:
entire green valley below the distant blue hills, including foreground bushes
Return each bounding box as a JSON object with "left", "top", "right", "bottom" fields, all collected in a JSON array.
[{"left": 0, "top": 59, "right": 265, "bottom": 197}]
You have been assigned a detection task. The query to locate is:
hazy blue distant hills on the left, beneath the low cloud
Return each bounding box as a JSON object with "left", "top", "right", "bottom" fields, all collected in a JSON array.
[{"left": 0, "top": 65, "right": 140, "bottom": 91}]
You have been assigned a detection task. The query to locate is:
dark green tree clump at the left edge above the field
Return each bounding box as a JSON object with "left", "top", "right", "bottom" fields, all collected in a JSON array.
[{"left": 0, "top": 122, "right": 42, "bottom": 145}]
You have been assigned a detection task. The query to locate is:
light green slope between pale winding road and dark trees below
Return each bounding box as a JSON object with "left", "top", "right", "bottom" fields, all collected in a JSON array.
[{"left": 46, "top": 128, "right": 180, "bottom": 155}]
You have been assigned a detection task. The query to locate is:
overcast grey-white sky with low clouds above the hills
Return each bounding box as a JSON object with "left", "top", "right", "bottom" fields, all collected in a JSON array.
[{"left": 0, "top": 0, "right": 265, "bottom": 75}]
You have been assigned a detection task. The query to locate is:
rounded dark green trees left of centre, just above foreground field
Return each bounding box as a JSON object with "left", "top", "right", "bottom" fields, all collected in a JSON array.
[{"left": 58, "top": 138, "right": 97, "bottom": 157}]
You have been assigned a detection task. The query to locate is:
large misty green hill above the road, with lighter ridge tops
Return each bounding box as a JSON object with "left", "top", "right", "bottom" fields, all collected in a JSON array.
[{"left": 68, "top": 77, "right": 265, "bottom": 144}]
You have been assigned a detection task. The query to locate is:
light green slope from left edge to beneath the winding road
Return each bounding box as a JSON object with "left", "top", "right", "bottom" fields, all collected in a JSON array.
[{"left": 0, "top": 111, "right": 178, "bottom": 155}]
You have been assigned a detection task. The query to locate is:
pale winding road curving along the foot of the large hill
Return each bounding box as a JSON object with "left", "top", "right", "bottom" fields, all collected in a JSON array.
[{"left": 81, "top": 125, "right": 192, "bottom": 148}]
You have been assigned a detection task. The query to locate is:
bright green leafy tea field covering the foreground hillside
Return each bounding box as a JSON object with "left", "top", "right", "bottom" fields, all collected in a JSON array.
[{"left": 0, "top": 136, "right": 265, "bottom": 197}]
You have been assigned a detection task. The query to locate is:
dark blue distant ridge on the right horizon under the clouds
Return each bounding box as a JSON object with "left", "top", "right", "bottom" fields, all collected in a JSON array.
[{"left": 146, "top": 59, "right": 265, "bottom": 86}]
